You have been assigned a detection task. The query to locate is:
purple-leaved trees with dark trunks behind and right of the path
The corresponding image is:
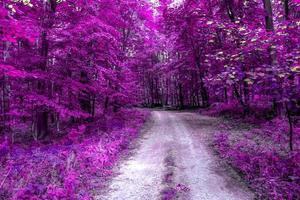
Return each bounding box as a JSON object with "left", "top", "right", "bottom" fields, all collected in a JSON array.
[{"left": 135, "top": 0, "right": 300, "bottom": 149}]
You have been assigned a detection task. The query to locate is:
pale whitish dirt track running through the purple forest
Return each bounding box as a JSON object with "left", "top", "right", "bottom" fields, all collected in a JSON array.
[{"left": 96, "top": 111, "right": 253, "bottom": 200}]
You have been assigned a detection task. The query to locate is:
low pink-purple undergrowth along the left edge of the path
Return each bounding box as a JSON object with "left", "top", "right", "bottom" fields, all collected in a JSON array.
[{"left": 0, "top": 110, "right": 148, "bottom": 200}]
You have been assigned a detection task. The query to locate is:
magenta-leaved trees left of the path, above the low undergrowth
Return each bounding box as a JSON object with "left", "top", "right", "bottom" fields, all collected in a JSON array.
[{"left": 0, "top": 0, "right": 152, "bottom": 143}]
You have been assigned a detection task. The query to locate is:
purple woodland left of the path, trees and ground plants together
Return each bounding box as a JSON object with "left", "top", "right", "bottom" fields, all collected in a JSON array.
[{"left": 0, "top": 0, "right": 153, "bottom": 200}]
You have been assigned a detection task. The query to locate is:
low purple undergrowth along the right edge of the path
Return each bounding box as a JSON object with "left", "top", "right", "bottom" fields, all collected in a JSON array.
[{"left": 202, "top": 103, "right": 300, "bottom": 200}]
